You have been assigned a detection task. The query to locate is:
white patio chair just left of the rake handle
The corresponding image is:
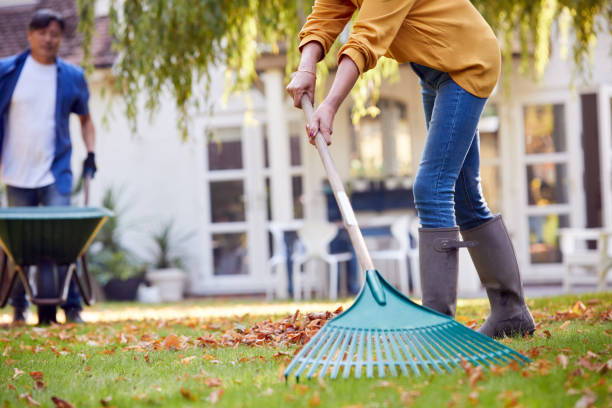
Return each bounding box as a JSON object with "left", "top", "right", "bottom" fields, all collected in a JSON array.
[{"left": 292, "top": 221, "right": 353, "bottom": 300}]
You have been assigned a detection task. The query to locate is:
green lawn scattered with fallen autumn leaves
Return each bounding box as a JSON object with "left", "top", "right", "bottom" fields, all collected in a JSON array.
[{"left": 0, "top": 293, "right": 612, "bottom": 408}]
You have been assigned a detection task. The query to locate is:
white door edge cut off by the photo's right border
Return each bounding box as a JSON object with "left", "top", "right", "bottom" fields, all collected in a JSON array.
[{"left": 597, "top": 85, "right": 612, "bottom": 228}]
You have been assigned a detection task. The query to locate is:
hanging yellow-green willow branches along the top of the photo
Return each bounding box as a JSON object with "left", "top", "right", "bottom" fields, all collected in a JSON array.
[{"left": 77, "top": 0, "right": 612, "bottom": 136}]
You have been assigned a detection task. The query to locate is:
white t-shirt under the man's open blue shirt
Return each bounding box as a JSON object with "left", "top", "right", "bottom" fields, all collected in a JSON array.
[{"left": 1, "top": 56, "right": 57, "bottom": 188}]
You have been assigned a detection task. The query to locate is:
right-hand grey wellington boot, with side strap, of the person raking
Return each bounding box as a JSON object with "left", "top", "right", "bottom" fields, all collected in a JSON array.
[{"left": 461, "top": 214, "right": 535, "bottom": 338}]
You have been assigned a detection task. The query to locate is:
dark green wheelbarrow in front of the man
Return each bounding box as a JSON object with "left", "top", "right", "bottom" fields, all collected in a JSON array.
[{"left": 0, "top": 207, "right": 113, "bottom": 324}]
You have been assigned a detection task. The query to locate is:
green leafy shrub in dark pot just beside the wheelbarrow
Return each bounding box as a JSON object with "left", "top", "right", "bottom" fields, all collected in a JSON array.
[{"left": 87, "top": 188, "right": 142, "bottom": 285}]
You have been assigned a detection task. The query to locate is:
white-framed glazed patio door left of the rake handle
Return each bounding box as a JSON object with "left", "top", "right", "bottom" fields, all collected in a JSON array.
[{"left": 203, "top": 124, "right": 268, "bottom": 294}]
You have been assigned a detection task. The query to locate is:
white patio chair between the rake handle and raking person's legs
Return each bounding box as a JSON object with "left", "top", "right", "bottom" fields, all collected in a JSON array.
[{"left": 370, "top": 215, "right": 421, "bottom": 296}]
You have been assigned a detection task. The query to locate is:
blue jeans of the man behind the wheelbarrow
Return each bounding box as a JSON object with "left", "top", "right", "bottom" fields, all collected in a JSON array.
[{"left": 6, "top": 184, "right": 82, "bottom": 310}]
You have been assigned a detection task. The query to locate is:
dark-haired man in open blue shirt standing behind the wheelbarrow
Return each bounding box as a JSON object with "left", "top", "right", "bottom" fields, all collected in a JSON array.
[{"left": 0, "top": 9, "right": 96, "bottom": 324}]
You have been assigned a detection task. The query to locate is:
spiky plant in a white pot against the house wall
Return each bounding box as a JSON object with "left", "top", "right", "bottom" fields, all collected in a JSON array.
[{"left": 146, "top": 221, "right": 192, "bottom": 302}]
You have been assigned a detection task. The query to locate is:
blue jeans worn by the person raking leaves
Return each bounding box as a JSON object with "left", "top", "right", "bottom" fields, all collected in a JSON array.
[{"left": 411, "top": 63, "right": 493, "bottom": 230}]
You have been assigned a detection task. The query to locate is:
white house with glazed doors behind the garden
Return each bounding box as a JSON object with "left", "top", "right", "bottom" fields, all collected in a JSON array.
[{"left": 0, "top": 0, "right": 612, "bottom": 295}]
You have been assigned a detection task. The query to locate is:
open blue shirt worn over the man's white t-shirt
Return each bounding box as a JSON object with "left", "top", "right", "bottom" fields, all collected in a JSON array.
[{"left": 0, "top": 50, "right": 89, "bottom": 194}]
